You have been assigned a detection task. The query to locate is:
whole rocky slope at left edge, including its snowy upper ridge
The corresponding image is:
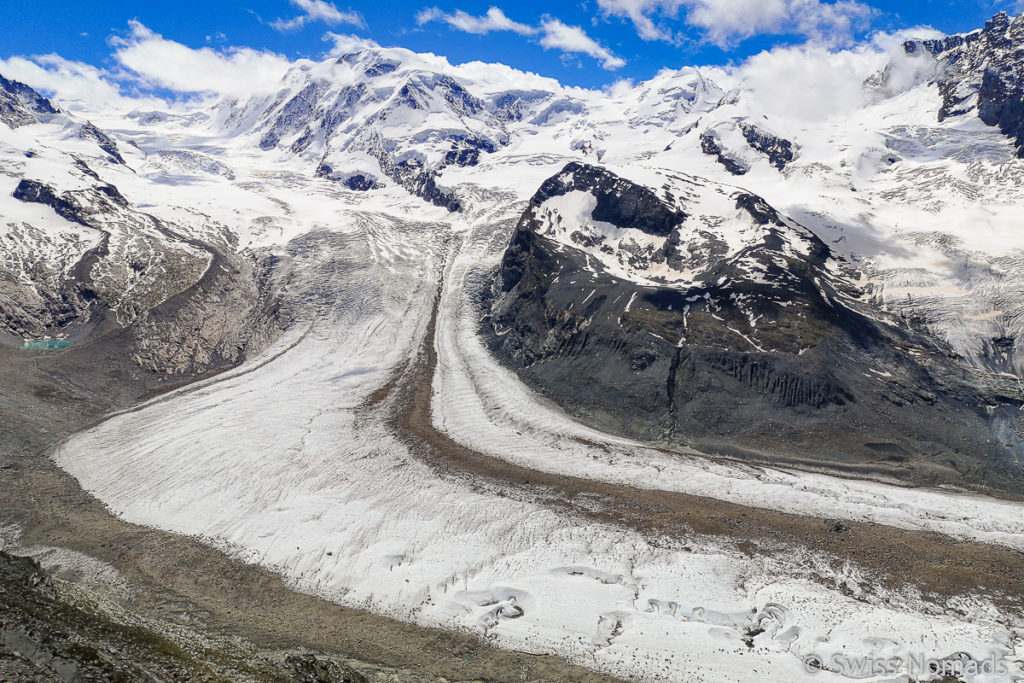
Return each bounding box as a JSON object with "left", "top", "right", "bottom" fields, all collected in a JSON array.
[{"left": 0, "top": 74, "right": 280, "bottom": 376}]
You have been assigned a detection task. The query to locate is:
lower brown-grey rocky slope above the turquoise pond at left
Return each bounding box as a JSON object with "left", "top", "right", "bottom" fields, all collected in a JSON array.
[{"left": 6, "top": 171, "right": 280, "bottom": 376}]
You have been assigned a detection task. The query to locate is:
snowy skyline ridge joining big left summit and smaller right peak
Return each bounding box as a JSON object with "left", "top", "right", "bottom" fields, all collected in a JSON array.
[{"left": 207, "top": 47, "right": 724, "bottom": 210}]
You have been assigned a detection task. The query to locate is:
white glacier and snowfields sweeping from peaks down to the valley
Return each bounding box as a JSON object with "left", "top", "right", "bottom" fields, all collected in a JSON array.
[{"left": 6, "top": 14, "right": 1024, "bottom": 681}]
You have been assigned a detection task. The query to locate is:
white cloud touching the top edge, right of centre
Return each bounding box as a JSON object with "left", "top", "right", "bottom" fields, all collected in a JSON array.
[{"left": 598, "top": 0, "right": 877, "bottom": 47}]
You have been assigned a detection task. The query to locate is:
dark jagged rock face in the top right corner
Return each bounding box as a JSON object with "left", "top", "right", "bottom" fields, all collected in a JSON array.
[{"left": 903, "top": 12, "right": 1024, "bottom": 157}]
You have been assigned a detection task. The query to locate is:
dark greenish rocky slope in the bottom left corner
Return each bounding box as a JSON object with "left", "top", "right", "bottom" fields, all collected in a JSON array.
[{"left": 0, "top": 551, "right": 366, "bottom": 683}]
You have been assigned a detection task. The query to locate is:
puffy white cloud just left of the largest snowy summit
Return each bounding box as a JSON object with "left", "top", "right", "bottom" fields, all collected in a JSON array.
[{"left": 112, "top": 22, "right": 291, "bottom": 96}]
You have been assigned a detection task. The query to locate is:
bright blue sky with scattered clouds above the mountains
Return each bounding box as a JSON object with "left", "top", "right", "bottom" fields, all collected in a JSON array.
[{"left": 0, "top": 0, "right": 1016, "bottom": 87}]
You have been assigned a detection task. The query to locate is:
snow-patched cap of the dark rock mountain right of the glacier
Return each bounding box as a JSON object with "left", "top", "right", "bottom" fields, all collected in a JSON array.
[{"left": 523, "top": 163, "right": 828, "bottom": 288}]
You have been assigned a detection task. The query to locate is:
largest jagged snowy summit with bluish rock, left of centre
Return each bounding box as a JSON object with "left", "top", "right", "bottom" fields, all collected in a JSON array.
[{"left": 211, "top": 48, "right": 541, "bottom": 210}]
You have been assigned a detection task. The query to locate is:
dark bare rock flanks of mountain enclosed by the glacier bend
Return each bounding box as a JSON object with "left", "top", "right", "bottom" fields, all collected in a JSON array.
[{"left": 484, "top": 162, "right": 1024, "bottom": 487}]
